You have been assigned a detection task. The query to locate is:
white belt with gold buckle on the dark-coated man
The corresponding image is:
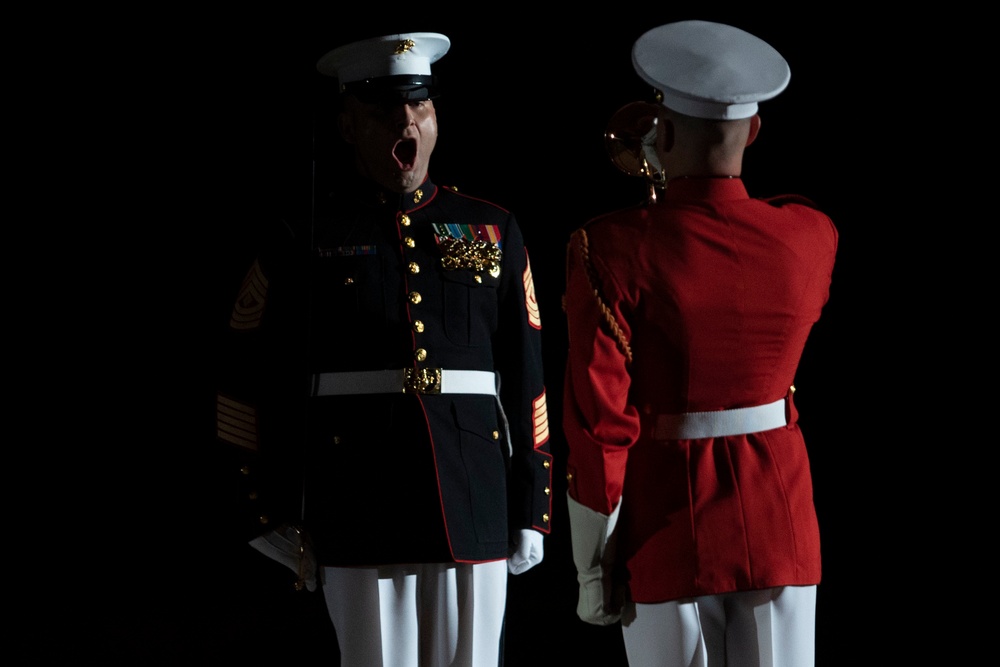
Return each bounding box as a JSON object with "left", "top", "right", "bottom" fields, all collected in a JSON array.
[{"left": 312, "top": 368, "right": 497, "bottom": 396}]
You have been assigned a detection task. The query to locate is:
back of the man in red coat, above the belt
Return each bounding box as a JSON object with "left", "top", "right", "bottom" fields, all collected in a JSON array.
[{"left": 572, "top": 178, "right": 837, "bottom": 413}]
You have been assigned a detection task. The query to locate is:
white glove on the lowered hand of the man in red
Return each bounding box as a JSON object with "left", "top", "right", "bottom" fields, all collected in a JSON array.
[{"left": 566, "top": 494, "right": 624, "bottom": 625}]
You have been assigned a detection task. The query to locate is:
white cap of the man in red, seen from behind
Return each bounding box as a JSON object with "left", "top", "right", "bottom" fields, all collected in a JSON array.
[{"left": 632, "top": 21, "right": 791, "bottom": 120}]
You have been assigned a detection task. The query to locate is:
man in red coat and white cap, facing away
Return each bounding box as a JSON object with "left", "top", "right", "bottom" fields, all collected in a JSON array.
[{"left": 564, "top": 21, "right": 838, "bottom": 667}]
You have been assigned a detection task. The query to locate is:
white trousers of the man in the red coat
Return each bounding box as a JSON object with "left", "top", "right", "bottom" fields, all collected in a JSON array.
[{"left": 622, "top": 586, "right": 816, "bottom": 667}]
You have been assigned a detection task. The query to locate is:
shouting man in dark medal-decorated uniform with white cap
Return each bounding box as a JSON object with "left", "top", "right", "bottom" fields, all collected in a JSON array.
[{"left": 218, "top": 33, "right": 551, "bottom": 667}]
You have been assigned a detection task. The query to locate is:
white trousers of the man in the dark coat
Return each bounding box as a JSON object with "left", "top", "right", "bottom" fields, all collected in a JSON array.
[{"left": 323, "top": 560, "right": 507, "bottom": 667}]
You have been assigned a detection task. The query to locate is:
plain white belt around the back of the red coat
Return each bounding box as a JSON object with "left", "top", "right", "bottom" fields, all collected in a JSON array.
[{"left": 653, "top": 398, "right": 788, "bottom": 440}]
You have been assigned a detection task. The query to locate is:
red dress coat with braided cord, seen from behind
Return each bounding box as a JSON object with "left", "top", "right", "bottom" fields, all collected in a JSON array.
[{"left": 563, "top": 178, "right": 838, "bottom": 603}]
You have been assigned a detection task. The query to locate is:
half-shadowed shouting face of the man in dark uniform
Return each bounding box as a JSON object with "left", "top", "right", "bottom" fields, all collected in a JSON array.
[{"left": 340, "top": 98, "right": 437, "bottom": 192}]
